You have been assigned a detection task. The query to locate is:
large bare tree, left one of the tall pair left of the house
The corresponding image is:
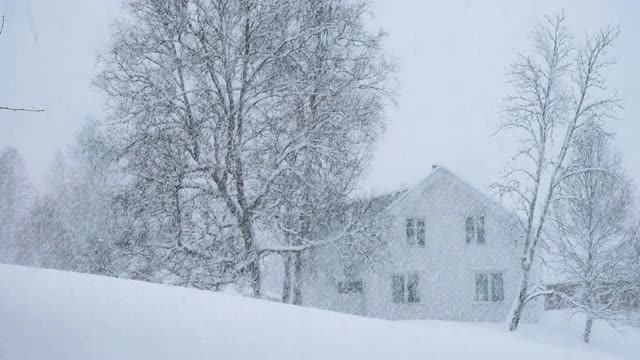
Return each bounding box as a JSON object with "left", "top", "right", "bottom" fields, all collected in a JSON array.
[{"left": 98, "top": 1, "right": 296, "bottom": 297}]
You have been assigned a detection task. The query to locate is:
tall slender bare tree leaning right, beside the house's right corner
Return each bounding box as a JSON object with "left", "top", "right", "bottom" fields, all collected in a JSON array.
[{"left": 494, "top": 14, "right": 619, "bottom": 331}]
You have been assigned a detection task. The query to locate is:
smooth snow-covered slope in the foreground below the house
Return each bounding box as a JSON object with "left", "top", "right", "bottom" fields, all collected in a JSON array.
[{"left": 0, "top": 265, "right": 640, "bottom": 360}]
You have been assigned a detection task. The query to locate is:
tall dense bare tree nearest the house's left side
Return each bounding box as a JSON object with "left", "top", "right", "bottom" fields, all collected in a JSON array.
[{"left": 256, "top": 0, "right": 394, "bottom": 304}]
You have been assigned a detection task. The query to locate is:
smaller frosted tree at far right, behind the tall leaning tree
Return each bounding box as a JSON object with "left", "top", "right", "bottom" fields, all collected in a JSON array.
[{"left": 547, "top": 130, "right": 636, "bottom": 342}]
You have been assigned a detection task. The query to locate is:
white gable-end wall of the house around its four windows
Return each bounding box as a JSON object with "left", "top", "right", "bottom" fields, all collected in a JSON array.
[{"left": 366, "top": 170, "right": 519, "bottom": 321}]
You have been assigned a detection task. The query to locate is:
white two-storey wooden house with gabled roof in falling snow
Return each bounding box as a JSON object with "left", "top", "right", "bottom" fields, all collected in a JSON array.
[{"left": 304, "top": 166, "right": 542, "bottom": 321}]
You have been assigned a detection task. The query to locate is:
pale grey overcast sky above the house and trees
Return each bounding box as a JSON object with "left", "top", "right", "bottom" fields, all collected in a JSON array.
[{"left": 0, "top": 0, "right": 640, "bottom": 197}]
